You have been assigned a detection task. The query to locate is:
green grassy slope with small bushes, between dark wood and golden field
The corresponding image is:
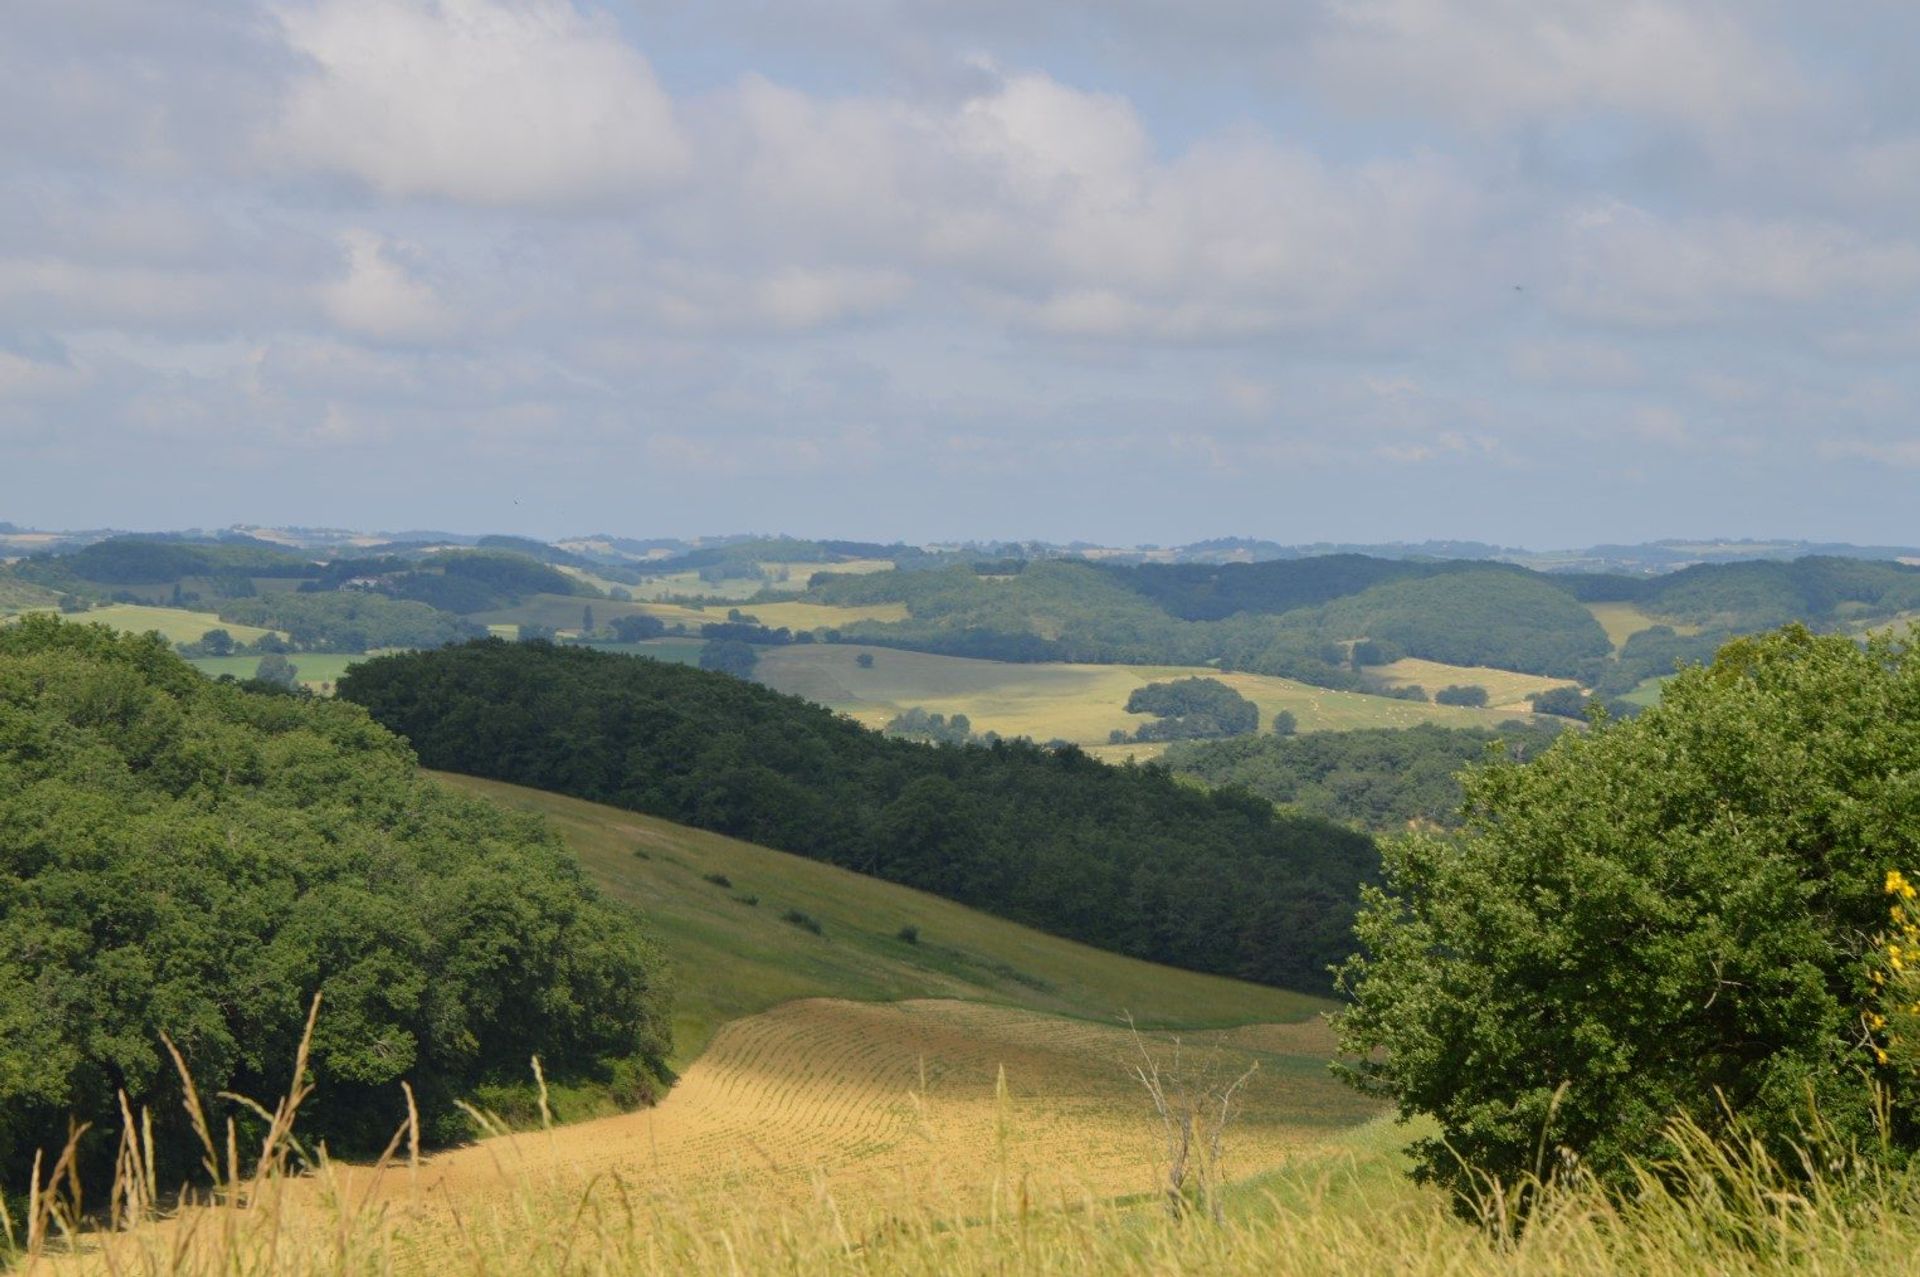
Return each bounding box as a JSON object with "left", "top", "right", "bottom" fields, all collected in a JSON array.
[{"left": 434, "top": 772, "right": 1332, "bottom": 1068}]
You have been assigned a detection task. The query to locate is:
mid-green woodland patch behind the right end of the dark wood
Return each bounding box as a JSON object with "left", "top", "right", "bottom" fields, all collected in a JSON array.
[{"left": 1162, "top": 722, "right": 1559, "bottom": 830}]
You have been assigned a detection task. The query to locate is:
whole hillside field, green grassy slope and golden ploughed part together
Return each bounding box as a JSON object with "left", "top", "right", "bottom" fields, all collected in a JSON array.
[{"left": 370, "top": 774, "right": 1380, "bottom": 1204}]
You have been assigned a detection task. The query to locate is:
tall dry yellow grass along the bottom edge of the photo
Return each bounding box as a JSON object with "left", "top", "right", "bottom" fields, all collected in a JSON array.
[{"left": 18, "top": 1020, "right": 1920, "bottom": 1277}]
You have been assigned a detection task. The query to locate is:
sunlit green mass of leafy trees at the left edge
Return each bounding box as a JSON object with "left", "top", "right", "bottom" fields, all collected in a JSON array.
[{"left": 0, "top": 616, "right": 668, "bottom": 1187}]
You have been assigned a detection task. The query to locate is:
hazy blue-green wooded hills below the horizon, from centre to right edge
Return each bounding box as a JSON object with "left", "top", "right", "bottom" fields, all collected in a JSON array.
[{"left": 808, "top": 555, "right": 1920, "bottom": 695}]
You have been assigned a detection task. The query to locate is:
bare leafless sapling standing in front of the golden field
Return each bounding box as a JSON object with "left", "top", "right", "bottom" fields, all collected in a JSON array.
[{"left": 1127, "top": 1014, "right": 1260, "bottom": 1221}]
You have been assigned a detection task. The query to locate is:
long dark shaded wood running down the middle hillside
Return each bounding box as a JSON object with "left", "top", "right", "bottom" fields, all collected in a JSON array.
[{"left": 340, "top": 641, "right": 1375, "bottom": 989}]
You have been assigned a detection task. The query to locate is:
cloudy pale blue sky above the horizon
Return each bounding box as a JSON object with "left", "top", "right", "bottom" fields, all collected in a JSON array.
[{"left": 0, "top": 0, "right": 1920, "bottom": 547}]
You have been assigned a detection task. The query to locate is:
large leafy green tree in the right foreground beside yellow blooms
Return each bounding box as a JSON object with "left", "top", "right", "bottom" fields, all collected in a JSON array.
[{"left": 1340, "top": 628, "right": 1920, "bottom": 1189}]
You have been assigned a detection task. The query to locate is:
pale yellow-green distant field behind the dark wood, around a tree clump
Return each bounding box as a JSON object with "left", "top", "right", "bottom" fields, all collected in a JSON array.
[{"left": 755, "top": 643, "right": 1526, "bottom": 757}]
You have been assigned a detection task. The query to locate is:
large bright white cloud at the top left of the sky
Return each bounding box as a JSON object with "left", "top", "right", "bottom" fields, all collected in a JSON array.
[{"left": 267, "top": 0, "right": 687, "bottom": 205}]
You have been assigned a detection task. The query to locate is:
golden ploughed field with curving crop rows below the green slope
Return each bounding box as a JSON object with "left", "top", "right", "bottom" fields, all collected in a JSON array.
[{"left": 405, "top": 999, "right": 1379, "bottom": 1204}]
